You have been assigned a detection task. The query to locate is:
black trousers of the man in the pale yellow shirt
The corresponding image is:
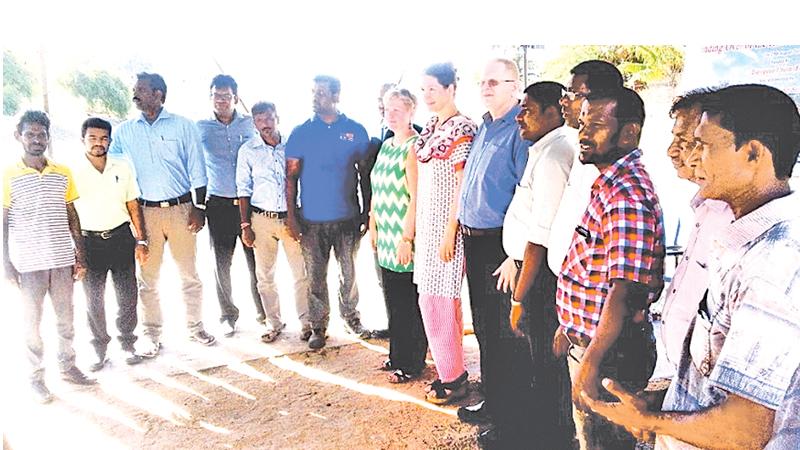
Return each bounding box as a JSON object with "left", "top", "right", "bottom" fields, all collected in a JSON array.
[{"left": 83, "top": 226, "right": 138, "bottom": 355}]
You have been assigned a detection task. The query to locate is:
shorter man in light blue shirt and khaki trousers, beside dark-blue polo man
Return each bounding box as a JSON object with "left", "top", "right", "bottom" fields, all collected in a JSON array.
[{"left": 236, "top": 102, "right": 311, "bottom": 343}]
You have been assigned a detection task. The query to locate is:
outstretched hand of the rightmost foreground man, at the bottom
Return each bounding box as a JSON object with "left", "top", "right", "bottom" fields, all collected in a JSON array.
[{"left": 581, "top": 378, "right": 655, "bottom": 442}]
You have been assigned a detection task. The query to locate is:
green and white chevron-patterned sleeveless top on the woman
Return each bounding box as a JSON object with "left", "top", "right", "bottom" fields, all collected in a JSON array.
[{"left": 371, "top": 135, "right": 418, "bottom": 272}]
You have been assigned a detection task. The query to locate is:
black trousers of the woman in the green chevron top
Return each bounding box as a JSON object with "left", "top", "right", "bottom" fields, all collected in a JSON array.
[{"left": 381, "top": 268, "right": 428, "bottom": 373}]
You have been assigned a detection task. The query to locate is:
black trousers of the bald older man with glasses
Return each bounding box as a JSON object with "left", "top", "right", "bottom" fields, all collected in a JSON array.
[{"left": 464, "top": 234, "right": 534, "bottom": 442}]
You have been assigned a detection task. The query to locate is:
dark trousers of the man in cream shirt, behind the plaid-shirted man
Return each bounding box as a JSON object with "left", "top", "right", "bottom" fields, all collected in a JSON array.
[{"left": 523, "top": 263, "right": 575, "bottom": 450}]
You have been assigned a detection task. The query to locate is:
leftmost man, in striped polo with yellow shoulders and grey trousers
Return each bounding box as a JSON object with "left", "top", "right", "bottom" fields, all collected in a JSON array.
[{"left": 3, "top": 111, "right": 95, "bottom": 403}]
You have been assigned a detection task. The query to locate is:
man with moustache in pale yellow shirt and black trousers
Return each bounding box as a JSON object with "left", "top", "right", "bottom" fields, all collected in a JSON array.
[{"left": 73, "top": 117, "right": 148, "bottom": 371}]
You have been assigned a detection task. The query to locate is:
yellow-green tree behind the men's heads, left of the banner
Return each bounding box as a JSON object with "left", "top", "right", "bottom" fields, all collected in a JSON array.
[{"left": 544, "top": 45, "right": 684, "bottom": 89}]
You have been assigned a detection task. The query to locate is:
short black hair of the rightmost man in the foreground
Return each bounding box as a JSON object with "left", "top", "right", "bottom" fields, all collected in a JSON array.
[{"left": 703, "top": 84, "right": 800, "bottom": 180}]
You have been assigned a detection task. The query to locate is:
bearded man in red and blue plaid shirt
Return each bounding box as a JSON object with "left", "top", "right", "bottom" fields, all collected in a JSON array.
[{"left": 554, "top": 88, "right": 664, "bottom": 449}]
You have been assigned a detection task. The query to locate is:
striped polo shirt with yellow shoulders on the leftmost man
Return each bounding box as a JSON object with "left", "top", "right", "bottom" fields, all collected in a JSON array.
[{"left": 3, "top": 159, "right": 78, "bottom": 273}]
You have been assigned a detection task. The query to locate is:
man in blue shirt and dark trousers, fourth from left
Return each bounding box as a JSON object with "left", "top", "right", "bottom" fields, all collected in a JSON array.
[{"left": 197, "top": 75, "right": 265, "bottom": 337}]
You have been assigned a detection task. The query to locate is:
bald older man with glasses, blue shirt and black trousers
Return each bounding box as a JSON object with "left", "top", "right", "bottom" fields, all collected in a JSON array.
[{"left": 458, "top": 59, "right": 534, "bottom": 446}]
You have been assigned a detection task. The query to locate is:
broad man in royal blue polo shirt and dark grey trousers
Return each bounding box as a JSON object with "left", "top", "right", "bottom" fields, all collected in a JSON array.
[{"left": 286, "top": 75, "right": 370, "bottom": 349}]
